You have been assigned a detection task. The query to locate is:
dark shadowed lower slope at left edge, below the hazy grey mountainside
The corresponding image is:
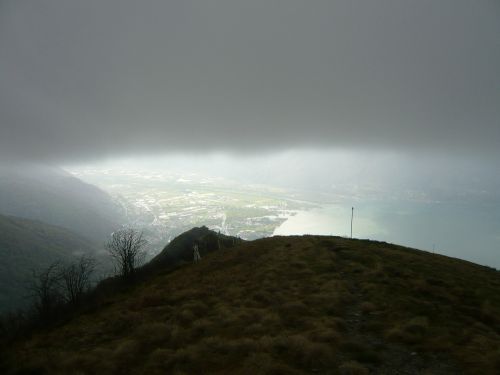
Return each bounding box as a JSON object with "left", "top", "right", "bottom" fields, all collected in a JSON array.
[{"left": 0, "top": 215, "right": 97, "bottom": 313}]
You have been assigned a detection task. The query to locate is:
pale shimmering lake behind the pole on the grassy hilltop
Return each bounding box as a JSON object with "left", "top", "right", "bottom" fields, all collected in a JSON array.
[{"left": 274, "top": 201, "right": 500, "bottom": 269}]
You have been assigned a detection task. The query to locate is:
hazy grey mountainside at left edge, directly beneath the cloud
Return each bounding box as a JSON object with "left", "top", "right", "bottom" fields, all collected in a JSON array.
[{"left": 0, "top": 165, "right": 124, "bottom": 244}]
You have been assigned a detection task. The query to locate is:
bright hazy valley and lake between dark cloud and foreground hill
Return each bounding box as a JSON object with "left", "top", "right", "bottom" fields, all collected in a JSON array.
[{"left": 66, "top": 150, "right": 500, "bottom": 267}]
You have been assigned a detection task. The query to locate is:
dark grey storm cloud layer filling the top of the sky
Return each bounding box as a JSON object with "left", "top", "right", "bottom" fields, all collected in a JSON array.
[{"left": 0, "top": 0, "right": 500, "bottom": 159}]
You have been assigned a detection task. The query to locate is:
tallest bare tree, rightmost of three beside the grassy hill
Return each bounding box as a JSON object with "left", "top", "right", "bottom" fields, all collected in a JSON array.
[{"left": 106, "top": 229, "right": 147, "bottom": 278}]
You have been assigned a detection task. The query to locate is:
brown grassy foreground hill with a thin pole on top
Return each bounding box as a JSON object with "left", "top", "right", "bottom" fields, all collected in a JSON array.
[{"left": 0, "top": 236, "right": 500, "bottom": 374}]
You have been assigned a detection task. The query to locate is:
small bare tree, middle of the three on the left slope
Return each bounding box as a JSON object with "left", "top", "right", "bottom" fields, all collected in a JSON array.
[{"left": 59, "top": 256, "right": 96, "bottom": 305}]
